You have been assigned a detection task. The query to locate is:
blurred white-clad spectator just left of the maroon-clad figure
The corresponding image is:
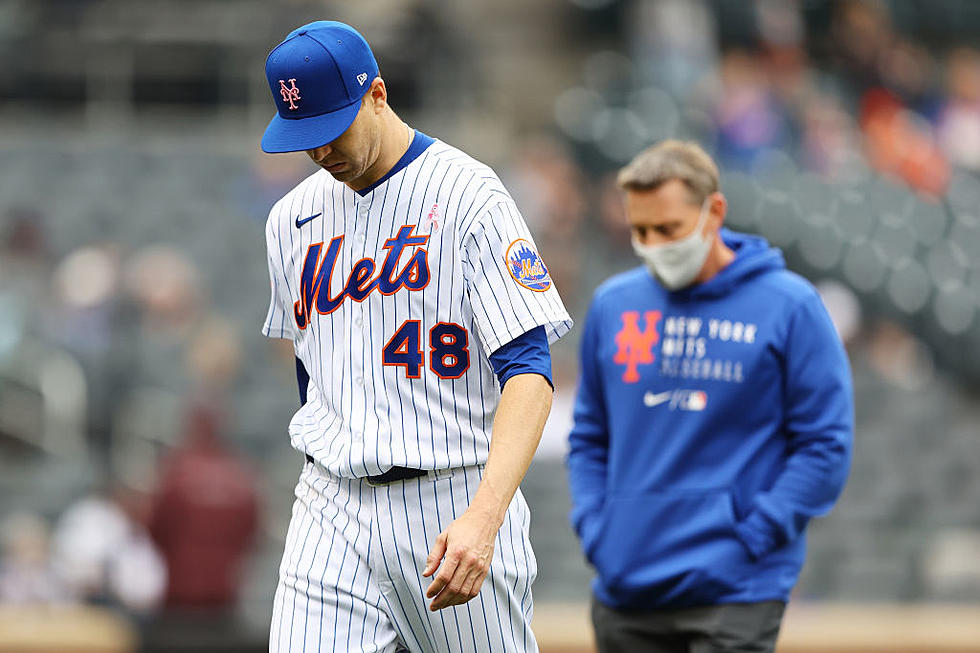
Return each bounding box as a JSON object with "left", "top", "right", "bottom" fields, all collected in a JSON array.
[{"left": 52, "top": 486, "right": 167, "bottom": 615}]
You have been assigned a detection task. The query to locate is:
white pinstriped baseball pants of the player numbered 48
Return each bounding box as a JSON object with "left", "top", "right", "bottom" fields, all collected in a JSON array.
[{"left": 269, "top": 463, "right": 538, "bottom": 653}]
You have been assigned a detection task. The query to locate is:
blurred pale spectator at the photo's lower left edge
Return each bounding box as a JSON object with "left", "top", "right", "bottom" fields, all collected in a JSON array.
[{"left": 0, "top": 512, "right": 68, "bottom": 604}]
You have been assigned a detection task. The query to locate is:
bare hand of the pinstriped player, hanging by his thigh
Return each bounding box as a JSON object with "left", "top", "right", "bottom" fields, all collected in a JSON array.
[{"left": 422, "top": 510, "right": 497, "bottom": 612}]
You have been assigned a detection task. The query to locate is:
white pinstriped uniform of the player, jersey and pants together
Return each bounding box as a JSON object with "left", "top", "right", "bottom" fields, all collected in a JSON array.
[{"left": 262, "top": 135, "right": 571, "bottom": 653}]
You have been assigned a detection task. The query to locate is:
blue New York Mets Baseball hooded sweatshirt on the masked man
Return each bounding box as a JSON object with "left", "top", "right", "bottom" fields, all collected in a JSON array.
[{"left": 568, "top": 229, "right": 853, "bottom": 609}]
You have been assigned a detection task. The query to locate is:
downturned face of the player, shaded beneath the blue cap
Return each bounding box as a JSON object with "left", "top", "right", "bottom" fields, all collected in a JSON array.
[{"left": 306, "top": 89, "right": 381, "bottom": 188}]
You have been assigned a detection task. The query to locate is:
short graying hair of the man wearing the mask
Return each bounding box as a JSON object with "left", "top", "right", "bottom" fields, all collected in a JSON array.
[{"left": 616, "top": 139, "right": 719, "bottom": 204}]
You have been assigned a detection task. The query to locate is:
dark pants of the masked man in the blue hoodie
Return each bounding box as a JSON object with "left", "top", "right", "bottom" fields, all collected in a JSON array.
[{"left": 592, "top": 598, "right": 786, "bottom": 653}]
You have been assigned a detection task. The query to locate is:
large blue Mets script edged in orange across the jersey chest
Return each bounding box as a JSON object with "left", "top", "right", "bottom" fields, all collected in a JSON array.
[{"left": 293, "top": 224, "right": 429, "bottom": 329}]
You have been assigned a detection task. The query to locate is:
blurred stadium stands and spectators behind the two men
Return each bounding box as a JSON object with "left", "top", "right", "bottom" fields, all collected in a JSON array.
[{"left": 0, "top": 0, "right": 980, "bottom": 651}]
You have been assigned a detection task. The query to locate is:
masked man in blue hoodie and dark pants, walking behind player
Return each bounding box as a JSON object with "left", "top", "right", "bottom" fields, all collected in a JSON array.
[{"left": 568, "top": 141, "right": 853, "bottom": 653}]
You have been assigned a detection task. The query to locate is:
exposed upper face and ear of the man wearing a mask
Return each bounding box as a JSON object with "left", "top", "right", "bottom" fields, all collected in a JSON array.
[{"left": 626, "top": 179, "right": 725, "bottom": 245}]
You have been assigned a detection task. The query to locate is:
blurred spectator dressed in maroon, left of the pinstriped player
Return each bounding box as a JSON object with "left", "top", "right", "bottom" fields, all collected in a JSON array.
[{"left": 150, "top": 407, "right": 258, "bottom": 611}]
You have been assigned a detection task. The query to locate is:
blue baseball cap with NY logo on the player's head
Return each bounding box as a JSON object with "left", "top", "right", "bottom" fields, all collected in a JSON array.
[{"left": 262, "top": 20, "right": 378, "bottom": 152}]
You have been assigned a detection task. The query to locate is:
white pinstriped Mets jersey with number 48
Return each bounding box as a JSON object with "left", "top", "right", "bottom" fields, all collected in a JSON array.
[{"left": 262, "top": 135, "right": 572, "bottom": 477}]
